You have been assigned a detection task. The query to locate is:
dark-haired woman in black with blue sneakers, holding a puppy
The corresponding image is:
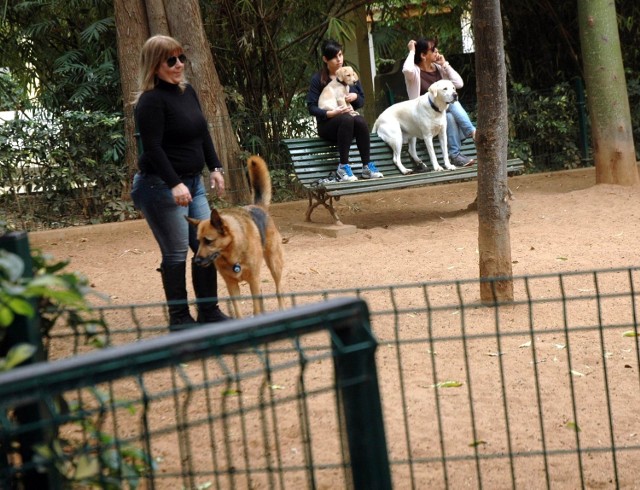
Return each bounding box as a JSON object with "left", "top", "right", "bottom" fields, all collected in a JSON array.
[{"left": 307, "top": 39, "right": 383, "bottom": 182}]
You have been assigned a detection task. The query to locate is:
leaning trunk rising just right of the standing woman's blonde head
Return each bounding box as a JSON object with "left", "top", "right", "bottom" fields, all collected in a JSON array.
[{"left": 165, "top": 0, "right": 251, "bottom": 203}]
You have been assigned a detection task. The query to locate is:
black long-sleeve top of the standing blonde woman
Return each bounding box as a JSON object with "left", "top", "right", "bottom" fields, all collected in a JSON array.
[{"left": 135, "top": 80, "right": 222, "bottom": 188}]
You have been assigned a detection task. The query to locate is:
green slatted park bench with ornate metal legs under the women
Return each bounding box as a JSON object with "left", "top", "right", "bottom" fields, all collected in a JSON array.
[{"left": 283, "top": 133, "right": 524, "bottom": 225}]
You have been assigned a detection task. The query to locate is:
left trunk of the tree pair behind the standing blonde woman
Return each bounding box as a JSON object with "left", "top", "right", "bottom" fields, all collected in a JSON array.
[{"left": 113, "top": 0, "right": 149, "bottom": 201}]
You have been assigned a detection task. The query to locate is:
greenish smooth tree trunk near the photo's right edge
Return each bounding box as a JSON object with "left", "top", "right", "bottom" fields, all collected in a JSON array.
[{"left": 578, "top": 0, "right": 638, "bottom": 185}]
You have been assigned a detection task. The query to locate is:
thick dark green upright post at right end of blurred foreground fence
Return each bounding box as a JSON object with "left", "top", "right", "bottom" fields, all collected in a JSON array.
[{"left": 333, "top": 302, "right": 392, "bottom": 490}]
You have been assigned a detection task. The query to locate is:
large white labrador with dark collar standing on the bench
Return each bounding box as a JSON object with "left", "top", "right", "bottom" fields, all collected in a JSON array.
[{"left": 373, "top": 80, "right": 458, "bottom": 175}]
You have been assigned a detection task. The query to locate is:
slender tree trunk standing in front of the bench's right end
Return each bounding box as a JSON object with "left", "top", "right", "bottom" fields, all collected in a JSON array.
[{"left": 473, "top": 0, "right": 513, "bottom": 303}]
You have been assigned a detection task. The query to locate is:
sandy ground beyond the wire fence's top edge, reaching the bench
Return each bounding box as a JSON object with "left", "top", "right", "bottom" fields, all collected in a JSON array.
[{"left": 30, "top": 168, "right": 640, "bottom": 304}]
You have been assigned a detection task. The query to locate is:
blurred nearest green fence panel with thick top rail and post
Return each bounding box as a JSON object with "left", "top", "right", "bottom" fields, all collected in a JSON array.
[{"left": 0, "top": 299, "right": 390, "bottom": 489}]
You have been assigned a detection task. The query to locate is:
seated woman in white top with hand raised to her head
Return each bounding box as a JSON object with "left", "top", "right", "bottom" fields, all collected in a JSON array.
[{"left": 402, "top": 39, "right": 476, "bottom": 167}]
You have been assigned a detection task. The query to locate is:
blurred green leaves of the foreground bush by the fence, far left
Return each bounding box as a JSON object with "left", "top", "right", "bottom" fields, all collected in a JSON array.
[{"left": 0, "top": 249, "right": 155, "bottom": 489}]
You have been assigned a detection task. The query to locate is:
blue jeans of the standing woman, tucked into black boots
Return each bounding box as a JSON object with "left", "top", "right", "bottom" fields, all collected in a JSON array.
[{"left": 131, "top": 172, "right": 211, "bottom": 265}]
